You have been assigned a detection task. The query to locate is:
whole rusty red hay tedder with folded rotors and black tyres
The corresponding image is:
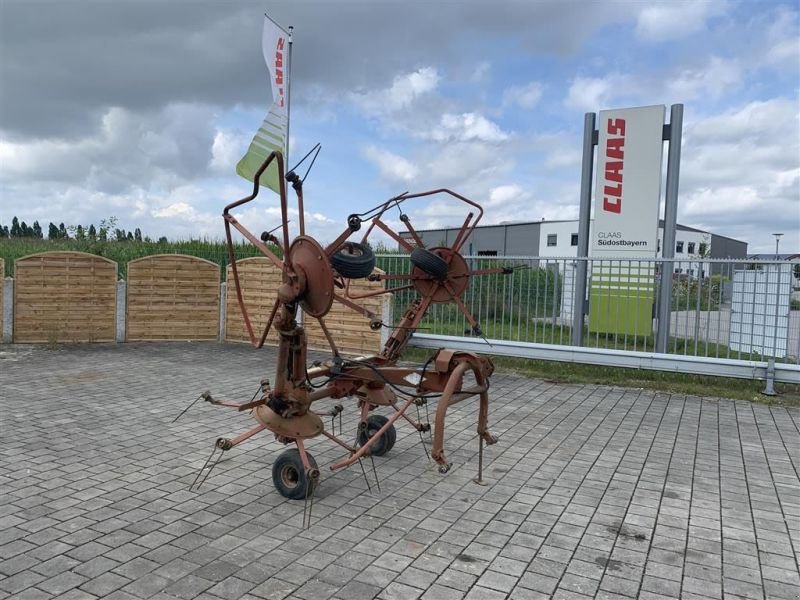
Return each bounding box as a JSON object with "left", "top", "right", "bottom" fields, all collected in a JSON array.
[{"left": 187, "top": 153, "right": 511, "bottom": 519}]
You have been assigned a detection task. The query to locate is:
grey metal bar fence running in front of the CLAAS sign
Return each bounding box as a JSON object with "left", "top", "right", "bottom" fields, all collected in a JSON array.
[{"left": 378, "top": 254, "right": 800, "bottom": 365}]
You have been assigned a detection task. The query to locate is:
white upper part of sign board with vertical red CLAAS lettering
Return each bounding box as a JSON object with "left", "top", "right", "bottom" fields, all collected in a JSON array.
[{"left": 592, "top": 105, "right": 666, "bottom": 257}]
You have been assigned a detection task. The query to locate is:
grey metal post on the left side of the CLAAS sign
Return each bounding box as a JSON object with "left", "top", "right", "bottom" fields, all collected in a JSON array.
[{"left": 572, "top": 113, "right": 596, "bottom": 346}]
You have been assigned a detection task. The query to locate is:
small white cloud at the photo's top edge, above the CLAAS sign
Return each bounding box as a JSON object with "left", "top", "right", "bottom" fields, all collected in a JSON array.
[{"left": 636, "top": 0, "right": 728, "bottom": 42}]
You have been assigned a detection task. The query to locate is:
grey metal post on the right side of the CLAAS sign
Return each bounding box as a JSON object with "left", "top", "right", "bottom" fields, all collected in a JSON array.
[{"left": 656, "top": 104, "right": 683, "bottom": 354}]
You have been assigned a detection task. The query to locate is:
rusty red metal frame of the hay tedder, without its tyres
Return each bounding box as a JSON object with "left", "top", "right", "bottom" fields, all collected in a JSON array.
[{"left": 204, "top": 152, "right": 510, "bottom": 500}]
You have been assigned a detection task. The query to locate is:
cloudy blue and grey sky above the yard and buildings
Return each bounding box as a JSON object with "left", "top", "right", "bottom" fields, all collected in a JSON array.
[{"left": 0, "top": 0, "right": 800, "bottom": 253}]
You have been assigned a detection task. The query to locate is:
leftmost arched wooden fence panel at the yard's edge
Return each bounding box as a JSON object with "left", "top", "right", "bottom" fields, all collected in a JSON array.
[{"left": 14, "top": 252, "right": 117, "bottom": 343}]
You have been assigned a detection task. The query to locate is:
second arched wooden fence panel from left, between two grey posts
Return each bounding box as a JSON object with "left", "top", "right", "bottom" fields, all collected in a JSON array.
[{"left": 125, "top": 254, "right": 220, "bottom": 342}]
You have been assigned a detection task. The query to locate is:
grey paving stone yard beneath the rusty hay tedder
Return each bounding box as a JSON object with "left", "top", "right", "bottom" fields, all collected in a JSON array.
[{"left": 0, "top": 343, "right": 800, "bottom": 600}]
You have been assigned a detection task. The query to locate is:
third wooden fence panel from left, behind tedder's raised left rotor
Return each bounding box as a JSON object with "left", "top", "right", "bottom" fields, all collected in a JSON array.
[{"left": 225, "top": 256, "right": 281, "bottom": 344}]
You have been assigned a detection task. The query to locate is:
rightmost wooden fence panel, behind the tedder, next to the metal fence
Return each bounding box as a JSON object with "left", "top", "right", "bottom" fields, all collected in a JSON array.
[{"left": 305, "top": 279, "right": 385, "bottom": 354}]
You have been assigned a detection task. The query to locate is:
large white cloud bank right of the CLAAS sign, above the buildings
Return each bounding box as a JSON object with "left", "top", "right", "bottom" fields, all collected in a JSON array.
[{"left": 679, "top": 98, "right": 800, "bottom": 252}]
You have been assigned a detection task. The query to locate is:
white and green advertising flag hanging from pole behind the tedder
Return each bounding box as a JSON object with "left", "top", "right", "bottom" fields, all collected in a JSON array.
[{"left": 236, "top": 16, "right": 289, "bottom": 192}]
